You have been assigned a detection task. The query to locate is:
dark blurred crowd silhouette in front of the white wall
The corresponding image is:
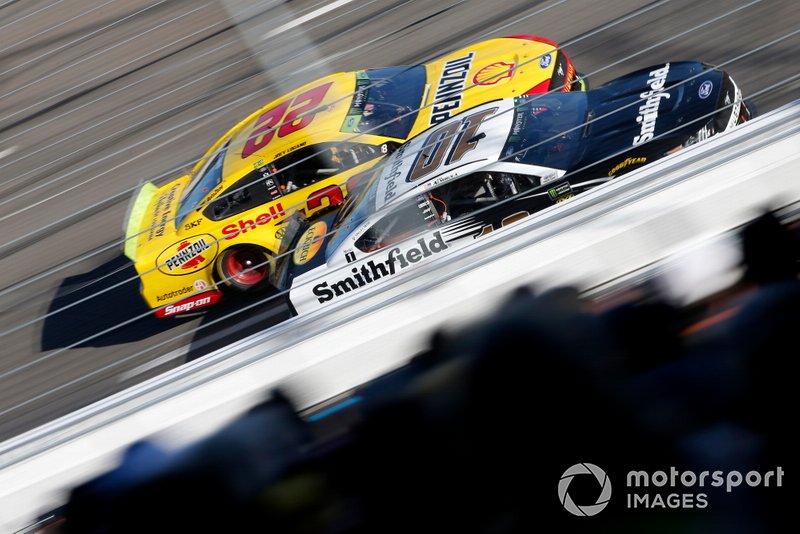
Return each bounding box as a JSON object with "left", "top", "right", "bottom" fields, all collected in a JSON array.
[{"left": 42, "top": 208, "right": 800, "bottom": 534}]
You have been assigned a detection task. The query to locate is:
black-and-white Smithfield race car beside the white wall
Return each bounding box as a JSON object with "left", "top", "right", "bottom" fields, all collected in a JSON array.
[{"left": 269, "top": 62, "right": 752, "bottom": 314}]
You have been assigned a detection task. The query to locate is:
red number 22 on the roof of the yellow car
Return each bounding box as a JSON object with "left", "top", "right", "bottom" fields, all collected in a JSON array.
[{"left": 242, "top": 82, "right": 333, "bottom": 159}]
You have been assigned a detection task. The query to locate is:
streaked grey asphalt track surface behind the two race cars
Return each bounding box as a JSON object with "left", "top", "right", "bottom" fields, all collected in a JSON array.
[{"left": 0, "top": 0, "right": 800, "bottom": 440}]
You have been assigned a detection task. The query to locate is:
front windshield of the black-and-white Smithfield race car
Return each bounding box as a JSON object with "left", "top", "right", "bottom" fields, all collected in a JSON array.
[{"left": 502, "top": 92, "right": 589, "bottom": 170}]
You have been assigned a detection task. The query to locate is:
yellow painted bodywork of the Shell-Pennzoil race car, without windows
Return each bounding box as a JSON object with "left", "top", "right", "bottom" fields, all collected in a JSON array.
[{"left": 124, "top": 38, "right": 575, "bottom": 309}]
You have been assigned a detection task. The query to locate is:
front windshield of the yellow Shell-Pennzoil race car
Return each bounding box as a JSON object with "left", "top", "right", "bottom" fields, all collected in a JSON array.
[{"left": 342, "top": 66, "right": 425, "bottom": 139}]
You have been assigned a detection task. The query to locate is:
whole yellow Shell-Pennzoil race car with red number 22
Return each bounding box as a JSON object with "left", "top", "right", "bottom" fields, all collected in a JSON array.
[{"left": 124, "top": 35, "right": 585, "bottom": 317}]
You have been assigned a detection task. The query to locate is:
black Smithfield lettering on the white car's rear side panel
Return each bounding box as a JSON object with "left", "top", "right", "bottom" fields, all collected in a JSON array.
[{"left": 312, "top": 232, "right": 447, "bottom": 304}]
